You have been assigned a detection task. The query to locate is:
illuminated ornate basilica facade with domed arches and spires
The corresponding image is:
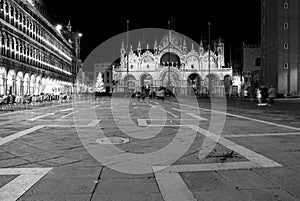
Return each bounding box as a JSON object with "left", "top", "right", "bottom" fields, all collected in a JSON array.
[{"left": 112, "top": 31, "right": 232, "bottom": 95}]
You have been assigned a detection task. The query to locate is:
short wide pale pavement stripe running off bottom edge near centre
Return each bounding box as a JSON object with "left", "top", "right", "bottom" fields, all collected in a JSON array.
[{"left": 155, "top": 172, "right": 197, "bottom": 201}]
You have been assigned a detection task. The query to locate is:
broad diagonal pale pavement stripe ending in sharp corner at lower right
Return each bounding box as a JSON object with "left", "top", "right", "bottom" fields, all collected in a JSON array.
[{"left": 189, "top": 125, "right": 282, "bottom": 167}]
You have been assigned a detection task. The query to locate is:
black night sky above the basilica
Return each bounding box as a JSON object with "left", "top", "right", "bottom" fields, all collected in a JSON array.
[{"left": 44, "top": 0, "right": 260, "bottom": 60}]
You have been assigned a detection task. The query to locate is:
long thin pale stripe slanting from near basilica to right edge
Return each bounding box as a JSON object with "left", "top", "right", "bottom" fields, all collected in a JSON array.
[{"left": 166, "top": 101, "right": 300, "bottom": 131}]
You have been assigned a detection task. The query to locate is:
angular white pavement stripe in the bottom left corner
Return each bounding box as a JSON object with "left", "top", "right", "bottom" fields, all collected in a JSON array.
[{"left": 0, "top": 168, "right": 52, "bottom": 201}]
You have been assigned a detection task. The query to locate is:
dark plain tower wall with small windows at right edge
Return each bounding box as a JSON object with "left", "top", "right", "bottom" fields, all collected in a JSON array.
[{"left": 261, "top": 0, "right": 300, "bottom": 94}]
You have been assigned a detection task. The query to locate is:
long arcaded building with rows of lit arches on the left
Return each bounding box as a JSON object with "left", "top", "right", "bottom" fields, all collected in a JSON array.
[{"left": 0, "top": 0, "right": 80, "bottom": 95}]
